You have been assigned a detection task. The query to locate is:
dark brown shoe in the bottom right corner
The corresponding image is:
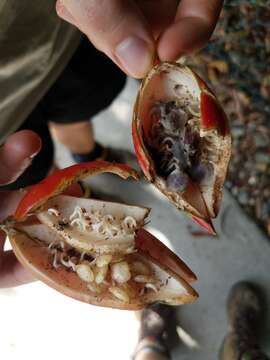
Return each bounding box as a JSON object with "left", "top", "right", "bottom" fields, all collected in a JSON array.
[{"left": 220, "top": 282, "right": 269, "bottom": 360}]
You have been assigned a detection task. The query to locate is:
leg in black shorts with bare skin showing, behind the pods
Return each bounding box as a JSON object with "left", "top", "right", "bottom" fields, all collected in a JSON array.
[{"left": 42, "top": 37, "right": 126, "bottom": 162}]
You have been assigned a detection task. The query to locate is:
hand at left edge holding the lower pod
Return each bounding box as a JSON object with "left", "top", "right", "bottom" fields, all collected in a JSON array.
[{"left": 0, "top": 130, "right": 41, "bottom": 287}]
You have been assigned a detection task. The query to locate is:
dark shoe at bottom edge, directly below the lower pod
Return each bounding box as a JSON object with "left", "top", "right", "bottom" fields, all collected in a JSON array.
[{"left": 133, "top": 303, "right": 178, "bottom": 360}]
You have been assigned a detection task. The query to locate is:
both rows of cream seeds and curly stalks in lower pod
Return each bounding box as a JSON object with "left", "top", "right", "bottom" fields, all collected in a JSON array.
[{"left": 47, "top": 206, "right": 160, "bottom": 303}]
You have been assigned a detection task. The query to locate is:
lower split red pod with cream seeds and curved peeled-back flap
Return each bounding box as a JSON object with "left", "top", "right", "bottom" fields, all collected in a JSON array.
[{"left": 3, "top": 161, "right": 197, "bottom": 310}]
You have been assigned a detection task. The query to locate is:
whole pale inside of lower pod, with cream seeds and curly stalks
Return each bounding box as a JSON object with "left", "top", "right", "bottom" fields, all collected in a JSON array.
[{"left": 16, "top": 195, "right": 193, "bottom": 304}]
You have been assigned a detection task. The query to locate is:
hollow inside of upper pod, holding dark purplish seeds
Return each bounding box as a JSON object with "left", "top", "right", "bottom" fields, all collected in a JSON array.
[{"left": 139, "top": 67, "right": 217, "bottom": 212}]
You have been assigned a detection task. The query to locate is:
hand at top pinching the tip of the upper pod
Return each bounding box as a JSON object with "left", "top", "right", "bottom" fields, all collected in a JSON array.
[{"left": 56, "top": 0, "right": 223, "bottom": 78}]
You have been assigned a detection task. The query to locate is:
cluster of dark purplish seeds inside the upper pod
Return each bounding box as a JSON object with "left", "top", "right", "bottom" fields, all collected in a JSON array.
[{"left": 149, "top": 95, "right": 212, "bottom": 192}]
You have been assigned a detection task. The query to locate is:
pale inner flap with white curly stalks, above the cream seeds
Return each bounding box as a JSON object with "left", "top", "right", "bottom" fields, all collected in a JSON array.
[{"left": 37, "top": 195, "right": 149, "bottom": 253}]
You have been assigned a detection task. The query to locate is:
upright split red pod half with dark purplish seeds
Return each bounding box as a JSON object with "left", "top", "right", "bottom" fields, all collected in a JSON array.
[{"left": 132, "top": 63, "right": 231, "bottom": 233}]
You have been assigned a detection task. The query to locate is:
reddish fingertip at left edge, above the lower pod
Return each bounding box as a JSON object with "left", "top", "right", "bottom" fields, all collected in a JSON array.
[{"left": 0, "top": 130, "right": 41, "bottom": 185}]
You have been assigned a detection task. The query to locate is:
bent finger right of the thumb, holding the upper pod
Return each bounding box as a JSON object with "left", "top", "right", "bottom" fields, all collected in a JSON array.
[{"left": 157, "top": 0, "right": 223, "bottom": 61}]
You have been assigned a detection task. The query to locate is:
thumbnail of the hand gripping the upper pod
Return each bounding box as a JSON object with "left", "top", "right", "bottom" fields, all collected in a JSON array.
[{"left": 115, "top": 36, "right": 153, "bottom": 78}]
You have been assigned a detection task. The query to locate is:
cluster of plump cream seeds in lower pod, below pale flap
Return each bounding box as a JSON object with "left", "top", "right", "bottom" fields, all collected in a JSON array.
[{"left": 48, "top": 242, "right": 160, "bottom": 302}]
